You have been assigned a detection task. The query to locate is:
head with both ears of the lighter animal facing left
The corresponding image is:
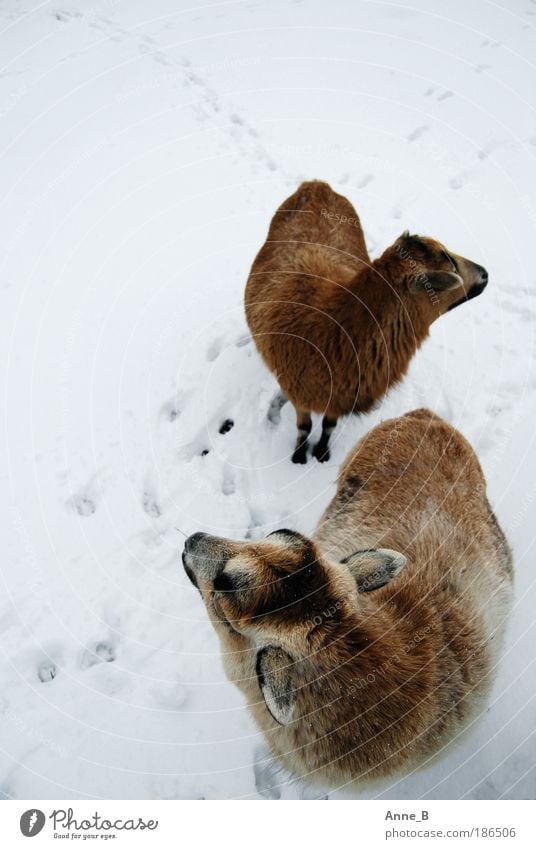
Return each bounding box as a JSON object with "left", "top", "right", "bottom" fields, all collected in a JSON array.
[{"left": 183, "top": 530, "right": 406, "bottom": 725}]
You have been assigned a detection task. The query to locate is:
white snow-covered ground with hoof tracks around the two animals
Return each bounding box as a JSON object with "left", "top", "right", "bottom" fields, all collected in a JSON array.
[{"left": 0, "top": 0, "right": 536, "bottom": 798}]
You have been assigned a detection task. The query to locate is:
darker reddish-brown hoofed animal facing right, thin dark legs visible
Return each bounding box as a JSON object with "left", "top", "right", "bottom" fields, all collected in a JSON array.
[{"left": 245, "top": 181, "right": 488, "bottom": 463}]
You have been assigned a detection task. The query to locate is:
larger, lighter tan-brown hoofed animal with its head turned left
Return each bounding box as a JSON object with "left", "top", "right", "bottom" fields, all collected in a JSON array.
[{"left": 183, "top": 410, "right": 513, "bottom": 786}]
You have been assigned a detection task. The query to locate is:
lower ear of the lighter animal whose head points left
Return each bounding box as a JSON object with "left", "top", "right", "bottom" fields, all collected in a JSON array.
[{"left": 256, "top": 646, "right": 296, "bottom": 725}]
